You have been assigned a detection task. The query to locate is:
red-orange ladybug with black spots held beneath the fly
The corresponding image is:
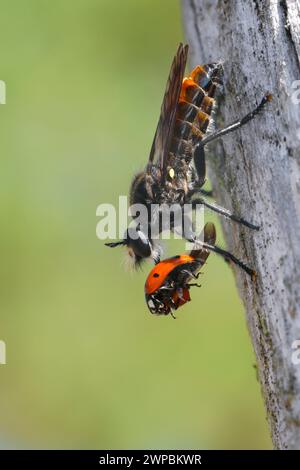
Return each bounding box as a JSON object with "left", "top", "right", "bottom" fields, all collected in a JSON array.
[{"left": 145, "top": 222, "right": 256, "bottom": 318}]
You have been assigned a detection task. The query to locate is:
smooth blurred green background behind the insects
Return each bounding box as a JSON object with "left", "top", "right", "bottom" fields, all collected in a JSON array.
[{"left": 0, "top": 0, "right": 271, "bottom": 449}]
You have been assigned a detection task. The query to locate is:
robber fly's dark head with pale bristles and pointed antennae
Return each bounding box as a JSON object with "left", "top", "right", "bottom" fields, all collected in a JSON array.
[{"left": 105, "top": 226, "right": 161, "bottom": 268}]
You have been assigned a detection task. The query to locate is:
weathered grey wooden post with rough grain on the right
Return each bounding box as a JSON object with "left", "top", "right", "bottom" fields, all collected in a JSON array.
[{"left": 182, "top": 0, "right": 300, "bottom": 449}]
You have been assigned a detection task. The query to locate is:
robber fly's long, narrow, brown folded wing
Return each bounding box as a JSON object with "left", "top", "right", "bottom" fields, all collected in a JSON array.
[{"left": 148, "top": 44, "right": 188, "bottom": 178}]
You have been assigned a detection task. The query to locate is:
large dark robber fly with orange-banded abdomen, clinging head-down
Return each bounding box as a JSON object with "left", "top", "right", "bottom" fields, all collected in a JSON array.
[{"left": 106, "top": 44, "right": 271, "bottom": 266}]
